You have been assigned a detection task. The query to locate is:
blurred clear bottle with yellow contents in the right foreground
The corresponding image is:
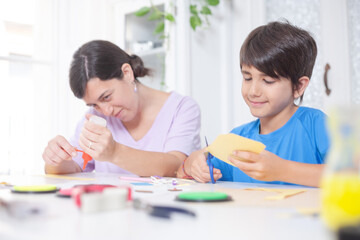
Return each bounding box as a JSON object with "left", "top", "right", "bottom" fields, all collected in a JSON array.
[{"left": 321, "top": 107, "right": 360, "bottom": 230}]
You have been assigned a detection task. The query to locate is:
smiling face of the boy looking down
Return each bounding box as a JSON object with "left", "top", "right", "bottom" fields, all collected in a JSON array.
[{"left": 241, "top": 65, "right": 294, "bottom": 121}]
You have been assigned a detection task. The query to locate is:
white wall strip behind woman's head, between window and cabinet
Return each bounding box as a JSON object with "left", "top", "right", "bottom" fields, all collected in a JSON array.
[{"left": 56, "top": 0, "right": 116, "bottom": 140}]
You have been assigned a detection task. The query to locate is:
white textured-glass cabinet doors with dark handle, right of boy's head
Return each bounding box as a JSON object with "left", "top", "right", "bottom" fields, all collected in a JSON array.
[{"left": 265, "top": 0, "right": 360, "bottom": 109}]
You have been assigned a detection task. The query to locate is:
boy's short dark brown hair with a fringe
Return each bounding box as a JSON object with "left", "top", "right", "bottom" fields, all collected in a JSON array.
[{"left": 240, "top": 22, "right": 317, "bottom": 103}]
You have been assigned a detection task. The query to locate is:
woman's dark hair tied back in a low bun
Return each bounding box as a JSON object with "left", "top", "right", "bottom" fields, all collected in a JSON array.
[{"left": 69, "top": 40, "right": 150, "bottom": 98}]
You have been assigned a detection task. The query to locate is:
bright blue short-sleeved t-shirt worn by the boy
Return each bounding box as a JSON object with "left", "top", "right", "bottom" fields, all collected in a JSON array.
[{"left": 212, "top": 107, "right": 330, "bottom": 184}]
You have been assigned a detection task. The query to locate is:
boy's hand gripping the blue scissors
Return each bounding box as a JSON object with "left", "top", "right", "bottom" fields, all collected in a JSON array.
[{"left": 184, "top": 148, "right": 222, "bottom": 183}]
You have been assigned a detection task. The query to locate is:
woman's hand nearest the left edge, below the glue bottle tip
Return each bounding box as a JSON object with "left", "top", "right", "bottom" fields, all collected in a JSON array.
[{"left": 42, "top": 135, "right": 77, "bottom": 166}]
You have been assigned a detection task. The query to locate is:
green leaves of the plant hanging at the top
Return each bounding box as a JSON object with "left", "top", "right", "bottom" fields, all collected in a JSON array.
[{"left": 134, "top": 0, "right": 220, "bottom": 38}]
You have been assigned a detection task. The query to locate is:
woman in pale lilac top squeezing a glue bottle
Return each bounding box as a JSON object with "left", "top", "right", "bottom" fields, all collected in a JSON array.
[{"left": 43, "top": 40, "right": 200, "bottom": 176}]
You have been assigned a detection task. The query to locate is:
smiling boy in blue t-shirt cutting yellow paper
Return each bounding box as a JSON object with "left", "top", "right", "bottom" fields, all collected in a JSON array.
[{"left": 178, "top": 22, "right": 329, "bottom": 186}]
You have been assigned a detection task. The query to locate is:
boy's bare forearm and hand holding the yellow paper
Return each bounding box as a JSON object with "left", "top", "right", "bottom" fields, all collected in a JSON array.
[{"left": 229, "top": 150, "right": 324, "bottom": 187}]
